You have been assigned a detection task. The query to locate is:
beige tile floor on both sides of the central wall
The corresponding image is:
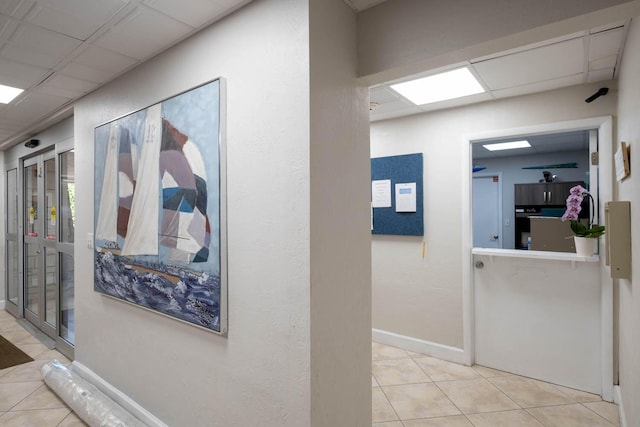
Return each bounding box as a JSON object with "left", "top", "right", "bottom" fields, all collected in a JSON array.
[{"left": 0, "top": 310, "right": 619, "bottom": 427}]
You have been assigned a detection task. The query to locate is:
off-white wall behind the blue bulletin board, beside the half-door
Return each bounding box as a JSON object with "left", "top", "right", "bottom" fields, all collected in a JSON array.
[{"left": 371, "top": 84, "right": 616, "bottom": 348}]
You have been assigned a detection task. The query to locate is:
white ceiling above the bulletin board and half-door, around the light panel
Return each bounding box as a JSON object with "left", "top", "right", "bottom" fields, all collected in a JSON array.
[{"left": 370, "top": 22, "right": 628, "bottom": 121}]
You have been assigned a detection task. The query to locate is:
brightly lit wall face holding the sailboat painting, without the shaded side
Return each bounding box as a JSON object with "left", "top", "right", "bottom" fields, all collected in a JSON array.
[{"left": 75, "top": 0, "right": 311, "bottom": 427}]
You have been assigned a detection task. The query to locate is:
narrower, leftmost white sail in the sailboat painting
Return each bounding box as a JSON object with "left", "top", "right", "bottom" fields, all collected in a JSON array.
[{"left": 96, "top": 123, "right": 119, "bottom": 242}]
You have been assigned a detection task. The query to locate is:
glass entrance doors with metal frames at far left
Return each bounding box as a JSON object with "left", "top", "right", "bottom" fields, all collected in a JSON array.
[{"left": 5, "top": 141, "right": 75, "bottom": 359}]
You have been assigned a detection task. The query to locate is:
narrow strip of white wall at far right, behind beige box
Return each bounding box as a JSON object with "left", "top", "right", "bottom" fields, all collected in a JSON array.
[{"left": 613, "top": 14, "right": 640, "bottom": 427}]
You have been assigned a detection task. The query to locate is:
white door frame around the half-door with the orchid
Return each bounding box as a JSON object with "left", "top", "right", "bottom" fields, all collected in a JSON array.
[{"left": 461, "top": 116, "right": 614, "bottom": 401}]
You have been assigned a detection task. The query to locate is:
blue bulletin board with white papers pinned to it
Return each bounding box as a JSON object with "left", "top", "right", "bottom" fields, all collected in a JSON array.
[{"left": 371, "top": 153, "right": 424, "bottom": 236}]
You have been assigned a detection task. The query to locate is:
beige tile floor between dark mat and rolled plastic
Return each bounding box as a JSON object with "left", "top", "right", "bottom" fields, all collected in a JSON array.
[{"left": 0, "top": 310, "right": 86, "bottom": 427}]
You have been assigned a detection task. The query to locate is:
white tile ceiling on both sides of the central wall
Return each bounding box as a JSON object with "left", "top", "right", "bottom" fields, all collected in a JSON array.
[{"left": 0, "top": 0, "right": 626, "bottom": 150}]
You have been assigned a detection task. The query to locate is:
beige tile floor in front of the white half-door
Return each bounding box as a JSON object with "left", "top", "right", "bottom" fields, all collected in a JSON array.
[{"left": 371, "top": 343, "right": 619, "bottom": 427}]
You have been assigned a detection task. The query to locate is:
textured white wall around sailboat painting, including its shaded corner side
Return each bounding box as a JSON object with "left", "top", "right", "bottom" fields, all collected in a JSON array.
[{"left": 75, "top": 0, "right": 371, "bottom": 427}]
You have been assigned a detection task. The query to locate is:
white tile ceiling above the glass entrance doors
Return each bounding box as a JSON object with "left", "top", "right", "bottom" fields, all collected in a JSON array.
[{"left": 0, "top": 0, "right": 251, "bottom": 149}]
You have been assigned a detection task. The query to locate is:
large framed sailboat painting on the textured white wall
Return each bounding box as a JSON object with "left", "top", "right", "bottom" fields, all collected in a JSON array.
[{"left": 94, "top": 80, "right": 226, "bottom": 334}]
